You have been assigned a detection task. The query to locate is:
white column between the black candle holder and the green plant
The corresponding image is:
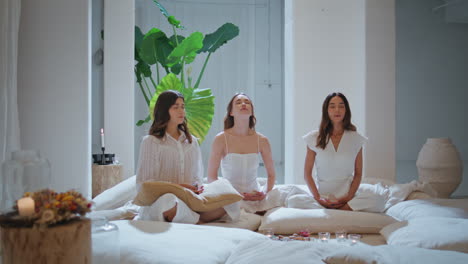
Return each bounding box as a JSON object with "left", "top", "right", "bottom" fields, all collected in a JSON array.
[{"left": 104, "top": 0, "right": 135, "bottom": 178}]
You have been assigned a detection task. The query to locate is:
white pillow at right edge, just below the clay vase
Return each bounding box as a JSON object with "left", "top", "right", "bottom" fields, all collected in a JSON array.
[{"left": 386, "top": 199, "right": 468, "bottom": 221}]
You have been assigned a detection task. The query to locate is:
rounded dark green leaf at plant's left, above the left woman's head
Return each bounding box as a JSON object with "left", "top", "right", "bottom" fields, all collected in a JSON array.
[{"left": 140, "top": 28, "right": 174, "bottom": 67}]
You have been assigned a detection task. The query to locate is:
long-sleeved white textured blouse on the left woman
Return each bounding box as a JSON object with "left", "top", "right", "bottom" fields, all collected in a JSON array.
[{"left": 136, "top": 133, "right": 203, "bottom": 190}]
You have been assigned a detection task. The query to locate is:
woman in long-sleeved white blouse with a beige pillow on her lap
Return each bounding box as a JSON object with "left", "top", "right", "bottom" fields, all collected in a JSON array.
[{"left": 136, "top": 90, "right": 226, "bottom": 224}]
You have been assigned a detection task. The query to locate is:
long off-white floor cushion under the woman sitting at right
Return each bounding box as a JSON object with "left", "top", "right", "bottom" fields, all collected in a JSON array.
[{"left": 259, "top": 207, "right": 396, "bottom": 234}]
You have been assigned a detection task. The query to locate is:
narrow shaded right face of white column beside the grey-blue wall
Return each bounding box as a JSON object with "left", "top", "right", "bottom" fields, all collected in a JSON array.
[{"left": 364, "top": 0, "right": 396, "bottom": 182}]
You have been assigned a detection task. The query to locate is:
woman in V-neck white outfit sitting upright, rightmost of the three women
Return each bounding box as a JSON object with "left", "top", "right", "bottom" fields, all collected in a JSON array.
[{"left": 303, "top": 93, "right": 367, "bottom": 210}]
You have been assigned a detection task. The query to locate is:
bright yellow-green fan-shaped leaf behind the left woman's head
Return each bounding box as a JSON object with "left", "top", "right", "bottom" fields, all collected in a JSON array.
[{"left": 149, "top": 73, "right": 214, "bottom": 143}]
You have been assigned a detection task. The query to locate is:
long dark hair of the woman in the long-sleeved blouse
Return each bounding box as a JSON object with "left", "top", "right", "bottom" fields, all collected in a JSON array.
[{"left": 149, "top": 90, "right": 192, "bottom": 144}]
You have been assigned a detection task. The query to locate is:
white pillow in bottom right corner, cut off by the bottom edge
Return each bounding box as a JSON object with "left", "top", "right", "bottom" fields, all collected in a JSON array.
[{"left": 324, "top": 244, "right": 468, "bottom": 264}]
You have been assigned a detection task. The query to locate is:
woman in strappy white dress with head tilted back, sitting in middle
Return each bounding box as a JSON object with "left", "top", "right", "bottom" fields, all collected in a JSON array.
[{"left": 208, "top": 93, "right": 275, "bottom": 213}]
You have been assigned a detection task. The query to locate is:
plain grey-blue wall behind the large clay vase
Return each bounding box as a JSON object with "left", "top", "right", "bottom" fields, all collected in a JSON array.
[{"left": 396, "top": 0, "right": 468, "bottom": 195}]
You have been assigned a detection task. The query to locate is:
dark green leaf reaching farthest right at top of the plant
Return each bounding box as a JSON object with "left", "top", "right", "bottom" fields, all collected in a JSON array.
[{"left": 198, "top": 23, "right": 239, "bottom": 53}]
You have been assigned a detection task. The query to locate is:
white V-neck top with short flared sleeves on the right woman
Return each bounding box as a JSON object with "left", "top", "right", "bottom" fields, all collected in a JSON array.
[{"left": 303, "top": 130, "right": 367, "bottom": 197}]
